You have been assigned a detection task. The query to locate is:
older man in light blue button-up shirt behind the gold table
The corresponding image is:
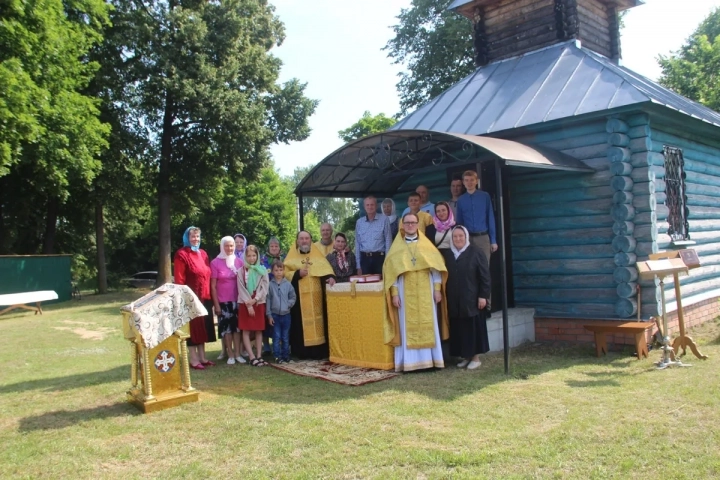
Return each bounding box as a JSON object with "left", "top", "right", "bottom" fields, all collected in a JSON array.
[{"left": 355, "top": 195, "right": 392, "bottom": 275}]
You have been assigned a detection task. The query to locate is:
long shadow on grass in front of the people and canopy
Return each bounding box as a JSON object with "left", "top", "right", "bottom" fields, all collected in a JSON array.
[{"left": 193, "top": 345, "right": 632, "bottom": 404}]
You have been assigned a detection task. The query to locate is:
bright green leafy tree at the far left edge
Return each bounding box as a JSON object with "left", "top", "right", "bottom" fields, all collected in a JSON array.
[{"left": 0, "top": 0, "right": 109, "bottom": 253}]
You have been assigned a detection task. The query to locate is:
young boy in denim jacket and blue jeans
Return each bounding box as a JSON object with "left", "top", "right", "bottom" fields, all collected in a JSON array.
[{"left": 266, "top": 260, "right": 296, "bottom": 363}]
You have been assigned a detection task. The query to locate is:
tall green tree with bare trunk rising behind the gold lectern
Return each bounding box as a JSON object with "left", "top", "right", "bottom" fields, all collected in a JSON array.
[{"left": 104, "top": 0, "right": 317, "bottom": 281}]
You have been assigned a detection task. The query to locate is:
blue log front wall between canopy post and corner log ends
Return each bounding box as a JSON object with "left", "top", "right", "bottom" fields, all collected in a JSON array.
[{"left": 509, "top": 119, "right": 616, "bottom": 318}]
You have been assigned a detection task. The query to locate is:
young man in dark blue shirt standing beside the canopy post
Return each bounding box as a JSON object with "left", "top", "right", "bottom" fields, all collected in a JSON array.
[{"left": 455, "top": 170, "right": 497, "bottom": 262}]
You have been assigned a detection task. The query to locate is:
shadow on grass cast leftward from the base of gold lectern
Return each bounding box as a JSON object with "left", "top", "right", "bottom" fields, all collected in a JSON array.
[{"left": 18, "top": 402, "right": 142, "bottom": 432}]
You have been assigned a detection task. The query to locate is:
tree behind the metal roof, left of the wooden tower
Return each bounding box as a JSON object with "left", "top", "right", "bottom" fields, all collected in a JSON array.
[{"left": 383, "top": 0, "right": 475, "bottom": 115}]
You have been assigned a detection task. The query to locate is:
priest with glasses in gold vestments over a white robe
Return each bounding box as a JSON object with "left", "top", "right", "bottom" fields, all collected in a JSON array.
[{"left": 383, "top": 213, "right": 449, "bottom": 372}]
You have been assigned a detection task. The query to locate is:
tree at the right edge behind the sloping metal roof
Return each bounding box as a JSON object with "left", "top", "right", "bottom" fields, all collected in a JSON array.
[{"left": 658, "top": 8, "right": 720, "bottom": 111}]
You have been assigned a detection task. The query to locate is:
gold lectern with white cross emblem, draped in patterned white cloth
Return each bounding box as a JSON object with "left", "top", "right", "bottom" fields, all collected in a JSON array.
[{"left": 120, "top": 284, "right": 207, "bottom": 413}]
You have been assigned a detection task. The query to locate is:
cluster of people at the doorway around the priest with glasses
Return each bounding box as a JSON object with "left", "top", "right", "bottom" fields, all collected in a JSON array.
[{"left": 355, "top": 170, "right": 497, "bottom": 371}]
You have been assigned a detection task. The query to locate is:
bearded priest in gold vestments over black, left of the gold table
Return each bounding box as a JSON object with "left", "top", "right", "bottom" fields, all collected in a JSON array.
[{"left": 284, "top": 231, "right": 335, "bottom": 360}]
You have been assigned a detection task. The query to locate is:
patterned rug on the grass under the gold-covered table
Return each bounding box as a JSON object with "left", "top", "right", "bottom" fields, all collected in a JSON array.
[{"left": 271, "top": 360, "right": 399, "bottom": 387}]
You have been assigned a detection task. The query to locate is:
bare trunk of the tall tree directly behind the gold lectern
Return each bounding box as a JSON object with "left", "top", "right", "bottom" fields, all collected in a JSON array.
[{"left": 157, "top": 91, "right": 174, "bottom": 285}]
